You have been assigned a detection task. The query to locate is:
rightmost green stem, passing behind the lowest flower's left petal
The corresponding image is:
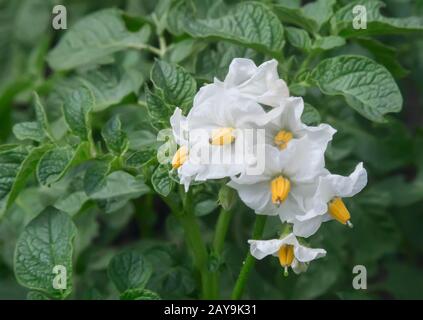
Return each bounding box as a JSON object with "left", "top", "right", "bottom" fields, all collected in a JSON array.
[{"left": 231, "top": 215, "right": 267, "bottom": 300}]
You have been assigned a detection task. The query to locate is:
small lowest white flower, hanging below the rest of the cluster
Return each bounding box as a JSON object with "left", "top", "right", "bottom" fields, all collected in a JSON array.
[{"left": 248, "top": 233, "right": 326, "bottom": 275}]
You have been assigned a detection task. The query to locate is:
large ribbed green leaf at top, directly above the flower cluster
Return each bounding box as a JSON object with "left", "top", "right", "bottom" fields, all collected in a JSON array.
[{"left": 180, "top": 2, "right": 284, "bottom": 56}]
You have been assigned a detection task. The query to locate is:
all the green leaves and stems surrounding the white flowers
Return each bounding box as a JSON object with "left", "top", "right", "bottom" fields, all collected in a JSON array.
[{"left": 0, "top": 0, "right": 423, "bottom": 300}]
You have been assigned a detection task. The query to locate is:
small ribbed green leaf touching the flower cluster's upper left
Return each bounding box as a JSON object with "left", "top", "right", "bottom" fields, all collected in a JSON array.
[{"left": 151, "top": 60, "right": 197, "bottom": 110}]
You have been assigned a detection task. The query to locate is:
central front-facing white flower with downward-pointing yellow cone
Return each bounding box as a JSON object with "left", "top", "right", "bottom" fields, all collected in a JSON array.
[{"left": 228, "top": 143, "right": 326, "bottom": 221}]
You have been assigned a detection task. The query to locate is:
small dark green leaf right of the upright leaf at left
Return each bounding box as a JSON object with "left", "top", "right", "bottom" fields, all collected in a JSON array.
[{"left": 101, "top": 116, "right": 129, "bottom": 155}]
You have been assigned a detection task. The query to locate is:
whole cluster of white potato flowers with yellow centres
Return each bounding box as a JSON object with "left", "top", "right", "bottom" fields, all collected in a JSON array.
[{"left": 171, "top": 59, "right": 367, "bottom": 272}]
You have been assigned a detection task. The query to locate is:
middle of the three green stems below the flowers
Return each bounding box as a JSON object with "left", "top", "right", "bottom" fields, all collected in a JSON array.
[{"left": 211, "top": 208, "right": 232, "bottom": 299}]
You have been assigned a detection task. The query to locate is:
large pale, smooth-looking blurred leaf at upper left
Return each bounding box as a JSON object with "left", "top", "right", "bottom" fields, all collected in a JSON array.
[{"left": 47, "top": 9, "right": 150, "bottom": 70}]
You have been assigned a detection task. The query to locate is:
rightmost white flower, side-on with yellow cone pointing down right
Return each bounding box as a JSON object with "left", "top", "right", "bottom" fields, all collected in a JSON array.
[{"left": 290, "top": 163, "right": 367, "bottom": 237}]
